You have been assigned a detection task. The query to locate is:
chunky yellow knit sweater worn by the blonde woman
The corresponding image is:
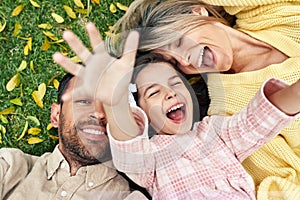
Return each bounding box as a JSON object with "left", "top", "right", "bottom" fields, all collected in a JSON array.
[{"left": 203, "top": 0, "right": 300, "bottom": 200}]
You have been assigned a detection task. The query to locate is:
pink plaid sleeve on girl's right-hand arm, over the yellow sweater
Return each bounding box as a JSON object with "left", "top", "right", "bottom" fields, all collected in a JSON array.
[{"left": 211, "top": 79, "right": 300, "bottom": 161}]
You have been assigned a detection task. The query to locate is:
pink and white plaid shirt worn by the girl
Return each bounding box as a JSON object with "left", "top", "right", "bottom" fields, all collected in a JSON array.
[{"left": 109, "top": 79, "right": 298, "bottom": 200}]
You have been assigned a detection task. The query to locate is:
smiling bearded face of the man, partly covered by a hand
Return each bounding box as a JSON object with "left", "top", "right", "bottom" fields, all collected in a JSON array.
[{"left": 52, "top": 78, "right": 111, "bottom": 165}]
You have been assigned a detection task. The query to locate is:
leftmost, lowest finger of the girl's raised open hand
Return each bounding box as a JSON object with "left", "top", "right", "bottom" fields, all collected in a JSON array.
[{"left": 53, "top": 52, "right": 83, "bottom": 76}]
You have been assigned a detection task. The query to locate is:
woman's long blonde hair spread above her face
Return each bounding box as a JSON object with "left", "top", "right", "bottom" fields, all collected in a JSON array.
[{"left": 106, "top": 0, "right": 228, "bottom": 57}]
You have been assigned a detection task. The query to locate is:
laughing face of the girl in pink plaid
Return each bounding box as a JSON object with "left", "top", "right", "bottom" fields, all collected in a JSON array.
[{"left": 136, "top": 62, "right": 193, "bottom": 134}]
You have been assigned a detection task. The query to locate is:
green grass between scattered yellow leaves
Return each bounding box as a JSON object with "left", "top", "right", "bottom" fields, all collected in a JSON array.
[{"left": 0, "top": 0, "right": 132, "bottom": 155}]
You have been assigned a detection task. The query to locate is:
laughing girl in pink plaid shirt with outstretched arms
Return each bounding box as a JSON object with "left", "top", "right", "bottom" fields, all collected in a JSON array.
[{"left": 54, "top": 25, "right": 300, "bottom": 199}]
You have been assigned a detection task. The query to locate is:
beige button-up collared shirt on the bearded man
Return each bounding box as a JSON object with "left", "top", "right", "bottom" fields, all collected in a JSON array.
[{"left": 0, "top": 147, "right": 144, "bottom": 200}]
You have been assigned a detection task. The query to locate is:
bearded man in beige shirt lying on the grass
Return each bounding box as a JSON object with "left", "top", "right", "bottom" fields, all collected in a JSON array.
[{"left": 0, "top": 74, "right": 146, "bottom": 199}]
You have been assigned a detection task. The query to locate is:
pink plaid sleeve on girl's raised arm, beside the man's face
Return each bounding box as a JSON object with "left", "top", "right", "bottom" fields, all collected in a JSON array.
[{"left": 107, "top": 106, "right": 154, "bottom": 188}]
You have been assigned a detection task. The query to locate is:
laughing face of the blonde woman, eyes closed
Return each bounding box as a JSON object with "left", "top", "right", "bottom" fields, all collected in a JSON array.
[{"left": 155, "top": 22, "right": 233, "bottom": 74}]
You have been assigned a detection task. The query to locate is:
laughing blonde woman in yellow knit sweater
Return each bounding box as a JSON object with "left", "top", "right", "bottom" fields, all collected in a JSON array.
[{"left": 108, "top": 0, "right": 300, "bottom": 199}]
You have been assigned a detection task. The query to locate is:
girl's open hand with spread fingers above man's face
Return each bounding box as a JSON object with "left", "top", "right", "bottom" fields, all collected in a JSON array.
[{"left": 53, "top": 23, "right": 139, "bottom": 106}]
